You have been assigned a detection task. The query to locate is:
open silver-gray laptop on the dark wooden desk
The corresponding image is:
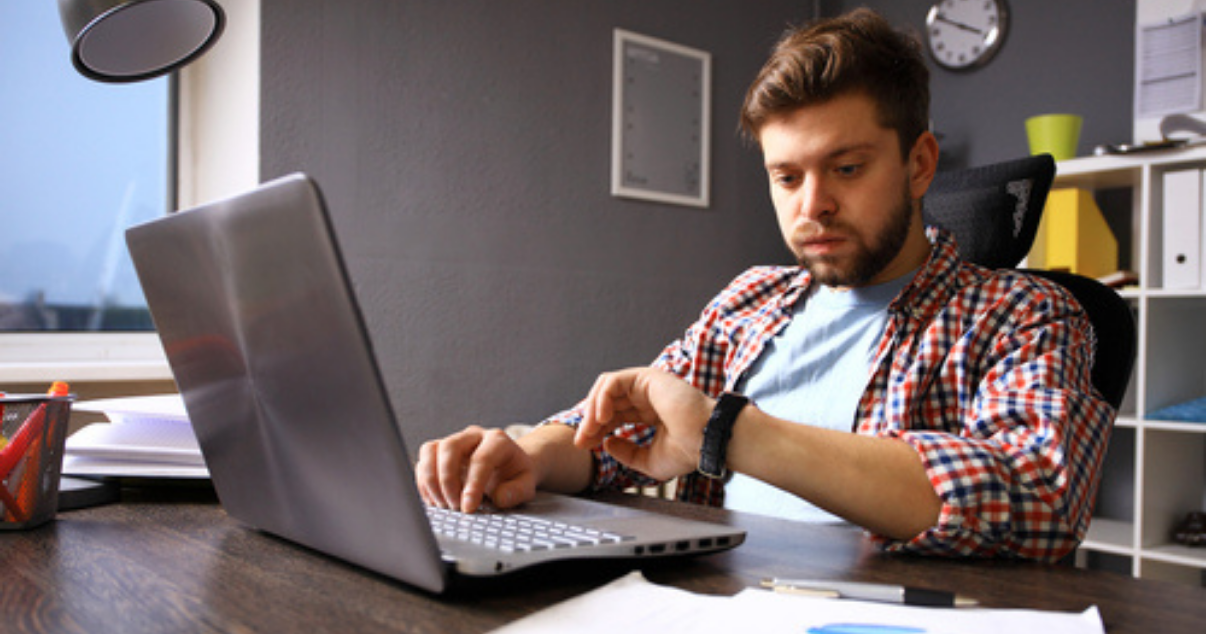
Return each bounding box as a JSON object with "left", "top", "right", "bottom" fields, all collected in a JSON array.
[{"left": 127, "top": 174, "right": 745, "bottom": 593}]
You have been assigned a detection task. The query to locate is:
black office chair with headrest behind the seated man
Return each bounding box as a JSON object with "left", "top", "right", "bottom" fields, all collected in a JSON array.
[{"left": 923, "top": 154, "right": 1138, "bottom": 410}]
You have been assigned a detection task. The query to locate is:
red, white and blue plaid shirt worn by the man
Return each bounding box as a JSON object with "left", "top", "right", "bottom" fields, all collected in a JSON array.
[{"left": 546, "top": 228, "right": 1114, "bottom": 560}]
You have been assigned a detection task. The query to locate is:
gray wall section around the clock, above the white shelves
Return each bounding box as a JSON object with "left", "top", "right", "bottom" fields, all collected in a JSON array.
[{"left": 863, "top": 0, "right": 1135, "bottom": 169}]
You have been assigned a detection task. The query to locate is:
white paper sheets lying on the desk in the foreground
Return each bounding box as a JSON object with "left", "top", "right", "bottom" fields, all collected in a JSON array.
[{"left": 494, "top": 573, "right": 1105, "bottom": 634}]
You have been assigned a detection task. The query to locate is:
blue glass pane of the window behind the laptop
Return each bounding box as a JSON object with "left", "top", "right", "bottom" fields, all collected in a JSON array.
[{"left": 0, "top": 0, "right": 172, "bottom": 336}]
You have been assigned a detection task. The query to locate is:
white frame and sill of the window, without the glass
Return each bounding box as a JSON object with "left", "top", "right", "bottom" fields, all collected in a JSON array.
[{"left": 0, "top": 0, "right": 260, "bottom": 384}]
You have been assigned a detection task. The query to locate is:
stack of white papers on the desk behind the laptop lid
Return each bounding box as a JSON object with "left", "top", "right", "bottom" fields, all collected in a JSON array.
[{"left": 63, "top": 394, "right": 210, "bottom": 479}]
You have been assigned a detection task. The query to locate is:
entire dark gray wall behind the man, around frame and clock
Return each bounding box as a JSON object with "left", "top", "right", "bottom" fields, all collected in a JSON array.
[{"left": 260, "top": 0, "right": 1134, "bottom": 446}]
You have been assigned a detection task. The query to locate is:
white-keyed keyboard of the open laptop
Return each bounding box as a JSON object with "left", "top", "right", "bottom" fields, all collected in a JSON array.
[{"left": 427, "top": 506, "right": 633, "bottom": 552}]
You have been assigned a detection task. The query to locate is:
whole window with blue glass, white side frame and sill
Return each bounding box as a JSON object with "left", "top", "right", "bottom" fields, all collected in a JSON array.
[{"left": 0, "top": 0, "right": 259, "bottom": 388}]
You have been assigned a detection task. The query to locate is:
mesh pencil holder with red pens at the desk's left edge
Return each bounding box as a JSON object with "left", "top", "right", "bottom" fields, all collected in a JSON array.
[{"left": 0, "top": 397, "right": 71, "bottom": 530}]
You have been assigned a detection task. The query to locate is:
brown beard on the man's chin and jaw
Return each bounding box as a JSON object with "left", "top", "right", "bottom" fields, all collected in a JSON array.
[{"left": 796, "top": 180, "right": 913, "bottom": 287}]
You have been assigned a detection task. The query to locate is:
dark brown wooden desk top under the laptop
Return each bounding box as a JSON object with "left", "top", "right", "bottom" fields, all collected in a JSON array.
[{"left": 0, "top": 489, "right": 1206, "bottom": 634}]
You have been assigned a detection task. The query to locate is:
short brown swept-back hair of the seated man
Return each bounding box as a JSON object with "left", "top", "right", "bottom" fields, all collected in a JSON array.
[{"left": 740, "top": 8, "right": 930, "bottom": 157}]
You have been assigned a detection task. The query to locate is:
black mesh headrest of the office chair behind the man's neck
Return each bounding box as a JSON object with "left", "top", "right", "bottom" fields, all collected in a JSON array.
[{"left": 923, "top": 154, "right": 1055, "bottom": 269}]
